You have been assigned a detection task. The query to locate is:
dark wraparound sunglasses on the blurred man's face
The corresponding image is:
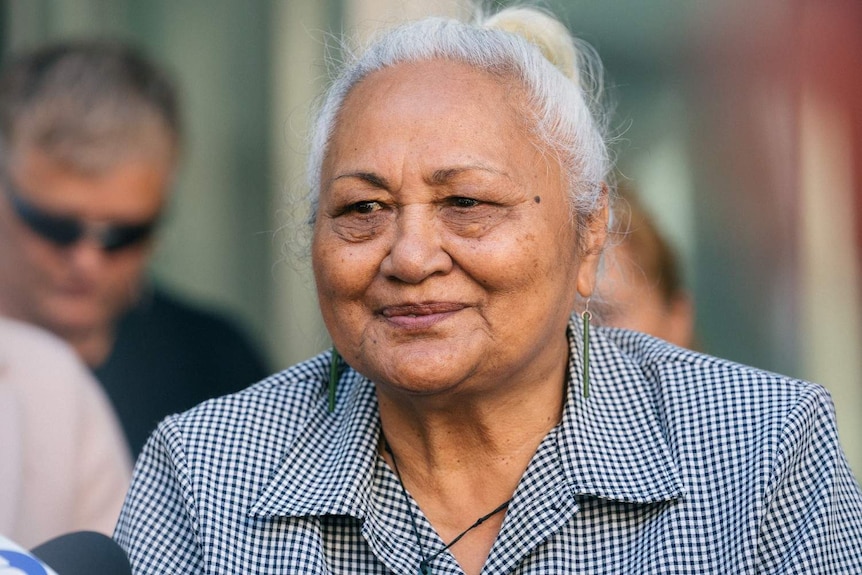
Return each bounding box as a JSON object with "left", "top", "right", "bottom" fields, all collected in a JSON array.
[{"left": 0, "top": 173, "right": 158, "bottom": 252}]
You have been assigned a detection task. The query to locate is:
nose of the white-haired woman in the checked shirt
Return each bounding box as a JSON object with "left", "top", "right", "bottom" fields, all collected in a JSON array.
[{"left": 380, "top": 204, "right": 453, "bottom": 284}]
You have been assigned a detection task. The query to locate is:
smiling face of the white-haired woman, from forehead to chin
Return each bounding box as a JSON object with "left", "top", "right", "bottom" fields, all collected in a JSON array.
[{"left": 312, "top": 61, "right": 595, "bottom": 394}]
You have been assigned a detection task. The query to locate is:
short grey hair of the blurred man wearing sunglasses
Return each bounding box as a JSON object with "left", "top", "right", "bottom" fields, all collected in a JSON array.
[{"left": 0, "top": 41, "right": 181, "bottom": 172}]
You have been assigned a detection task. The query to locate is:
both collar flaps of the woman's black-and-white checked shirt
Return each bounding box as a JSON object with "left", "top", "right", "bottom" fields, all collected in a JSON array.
[{"left": 249, "top": 320, "right": 684, "bottom": 519}]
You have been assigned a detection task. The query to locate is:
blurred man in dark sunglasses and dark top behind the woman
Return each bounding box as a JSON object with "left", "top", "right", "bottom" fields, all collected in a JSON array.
[{"left": 0, "top": 41, "right": 267, "bottom": 455}]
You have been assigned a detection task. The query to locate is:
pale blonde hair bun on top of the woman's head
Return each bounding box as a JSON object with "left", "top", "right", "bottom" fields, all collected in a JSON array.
[{"left": 483, "top": 7, "right": 580, "bottom": 84}]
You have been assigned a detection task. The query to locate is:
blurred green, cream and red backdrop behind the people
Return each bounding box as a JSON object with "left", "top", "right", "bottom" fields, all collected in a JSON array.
[{"left": 0, "top": 0, "right": 862, "bottom": 474}]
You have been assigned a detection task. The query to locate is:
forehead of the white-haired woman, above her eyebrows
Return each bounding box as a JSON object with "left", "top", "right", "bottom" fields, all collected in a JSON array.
[{"left": 321, "top": 59, "right": 548, "bottom": 178}]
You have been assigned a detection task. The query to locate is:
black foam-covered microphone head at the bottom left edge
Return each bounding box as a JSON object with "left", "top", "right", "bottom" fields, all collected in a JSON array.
[{"left": 31, "top": 531, "right": 132, "bottom": 575}]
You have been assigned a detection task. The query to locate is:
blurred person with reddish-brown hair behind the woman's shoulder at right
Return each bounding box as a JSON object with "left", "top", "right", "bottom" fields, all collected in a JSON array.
[{"left": 596, "top": 187, "right": 694, "bottom": 348}]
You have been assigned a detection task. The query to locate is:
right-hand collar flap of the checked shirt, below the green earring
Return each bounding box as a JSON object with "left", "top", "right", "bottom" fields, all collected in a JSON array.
[{"left": 560, "top": 318, "right": 685, "bottom": 503}]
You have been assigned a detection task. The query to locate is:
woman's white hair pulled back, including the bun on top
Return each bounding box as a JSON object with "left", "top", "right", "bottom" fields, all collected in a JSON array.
[{"left": 307, "top": 7, "right": 611, "bottom": 252}]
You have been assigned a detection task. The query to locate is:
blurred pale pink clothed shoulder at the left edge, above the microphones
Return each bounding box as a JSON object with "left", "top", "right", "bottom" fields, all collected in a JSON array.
[{"left": 0, "top": 317, "right": 132, "bottom": 547}]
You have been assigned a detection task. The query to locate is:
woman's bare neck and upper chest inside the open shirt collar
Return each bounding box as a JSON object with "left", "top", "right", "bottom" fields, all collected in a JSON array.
[{"left": 378, "top": 377, "right": 565, "bottom": 573}]
